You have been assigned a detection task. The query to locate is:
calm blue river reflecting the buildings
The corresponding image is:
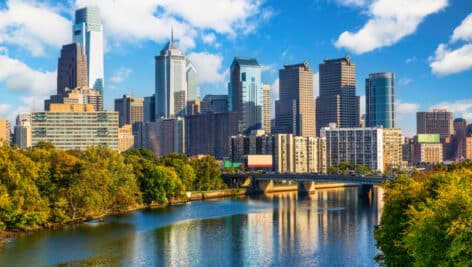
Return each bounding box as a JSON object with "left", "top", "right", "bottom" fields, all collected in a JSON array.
[{"left": 0, "top": 188, "right": 383, "bottom": 266}]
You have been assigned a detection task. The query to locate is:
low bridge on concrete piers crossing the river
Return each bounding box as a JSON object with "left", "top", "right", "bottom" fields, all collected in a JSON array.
[{"left": 222, "top": 172, "right": 389, "bottom": 197}]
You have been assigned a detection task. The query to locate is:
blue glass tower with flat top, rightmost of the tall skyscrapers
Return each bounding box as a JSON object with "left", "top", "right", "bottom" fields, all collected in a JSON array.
[{"left": 365, "top": 72, "right": 395, "bottom": 128}]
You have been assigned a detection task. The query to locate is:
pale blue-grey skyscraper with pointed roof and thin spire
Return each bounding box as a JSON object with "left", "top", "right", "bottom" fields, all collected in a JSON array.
[{"left": 155, "top": 33, "right": 187, "bottom": 119}]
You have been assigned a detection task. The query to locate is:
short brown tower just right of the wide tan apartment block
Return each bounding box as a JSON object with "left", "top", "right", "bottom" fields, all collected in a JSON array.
[{"left": 115, "top": 95, "right": 144, "bottom": 127}]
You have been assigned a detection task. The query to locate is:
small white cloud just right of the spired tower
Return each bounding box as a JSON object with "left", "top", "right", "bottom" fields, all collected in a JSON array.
[{"left": 188, "top": 52, "right": 225, "bottom": 83}]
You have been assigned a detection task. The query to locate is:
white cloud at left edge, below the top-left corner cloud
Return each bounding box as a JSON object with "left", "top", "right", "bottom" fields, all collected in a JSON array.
[{"left": 0, "top": 55, "right": 56, "bottom": 94}]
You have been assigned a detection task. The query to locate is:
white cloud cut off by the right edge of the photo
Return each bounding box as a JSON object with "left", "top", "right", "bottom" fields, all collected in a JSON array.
[{"left": 429, "top": 13, "right": 472, "bottom": 76}]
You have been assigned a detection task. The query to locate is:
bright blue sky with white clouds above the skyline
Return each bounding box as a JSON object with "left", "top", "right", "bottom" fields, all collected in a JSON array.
[{"left": 0, "top": 0, "right": 472, "bottom": 136}]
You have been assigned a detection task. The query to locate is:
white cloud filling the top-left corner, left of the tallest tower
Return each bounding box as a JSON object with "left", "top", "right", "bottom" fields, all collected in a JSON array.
[{"left": 0, "top": 0, "right": 72, "bottom": 56}]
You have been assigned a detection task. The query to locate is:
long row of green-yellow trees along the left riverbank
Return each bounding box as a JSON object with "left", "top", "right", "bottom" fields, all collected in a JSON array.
[{"left": 0, "top": 143, "right": 225, "bottom": 230}]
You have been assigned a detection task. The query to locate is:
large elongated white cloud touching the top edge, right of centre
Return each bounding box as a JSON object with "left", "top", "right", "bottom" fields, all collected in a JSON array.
[{"left": 335, "top": 0, "right": 447, "bottom": 54}]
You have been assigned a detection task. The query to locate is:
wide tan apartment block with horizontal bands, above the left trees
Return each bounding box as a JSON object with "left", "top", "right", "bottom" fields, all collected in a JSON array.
[{"left": 31, "top": 104, "right": 118, "bottom": 151}]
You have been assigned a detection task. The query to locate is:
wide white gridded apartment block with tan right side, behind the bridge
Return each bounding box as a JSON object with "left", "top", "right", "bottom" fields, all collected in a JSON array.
[{"left": 322, "top": 127, "right": 402, "bottom": 172}]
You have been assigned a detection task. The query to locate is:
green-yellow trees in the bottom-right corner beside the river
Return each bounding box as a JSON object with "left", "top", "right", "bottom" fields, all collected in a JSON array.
[{"left": 375, "top": 161, "right": 472, "bottom": 266}]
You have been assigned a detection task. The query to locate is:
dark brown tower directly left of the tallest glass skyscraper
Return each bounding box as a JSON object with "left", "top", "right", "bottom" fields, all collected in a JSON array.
[{"left": 57, "top": 43, "right": 88, "bottom": 96}]
